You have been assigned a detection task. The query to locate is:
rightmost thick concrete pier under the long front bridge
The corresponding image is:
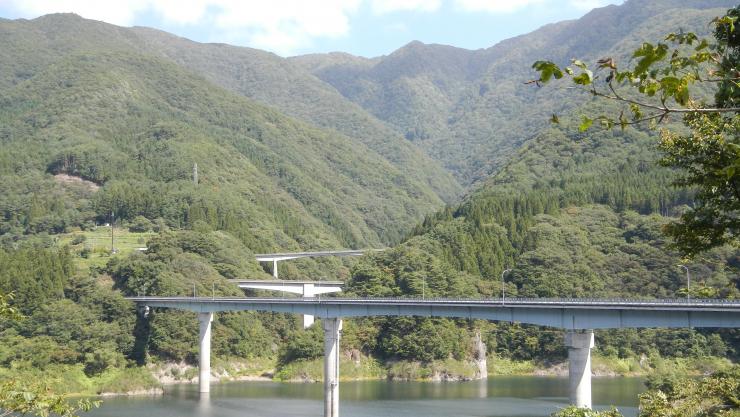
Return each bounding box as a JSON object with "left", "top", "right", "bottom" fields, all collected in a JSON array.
[{"left": 565, "top": 330, "right": 594, "bottom": 408}]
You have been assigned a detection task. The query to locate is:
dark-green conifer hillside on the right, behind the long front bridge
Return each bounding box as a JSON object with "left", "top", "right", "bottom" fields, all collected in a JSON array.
[{"left": 342, "top": 119, "right": 740, "bottom": 361}]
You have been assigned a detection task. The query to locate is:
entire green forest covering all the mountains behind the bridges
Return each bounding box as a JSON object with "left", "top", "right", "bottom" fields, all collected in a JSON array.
[{"left": 0, "top": 0, "right": 740, "bottom": 398}]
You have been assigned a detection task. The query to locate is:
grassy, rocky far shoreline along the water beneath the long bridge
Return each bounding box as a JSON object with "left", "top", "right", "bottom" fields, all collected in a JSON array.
[{"left": 20, "top": 355, "right": 732, "bottom": 398}]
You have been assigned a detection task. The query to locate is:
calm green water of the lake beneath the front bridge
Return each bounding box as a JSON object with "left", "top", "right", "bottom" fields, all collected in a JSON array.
[{"left": 86, "top": 377, "right": 645, "bottom": 417}]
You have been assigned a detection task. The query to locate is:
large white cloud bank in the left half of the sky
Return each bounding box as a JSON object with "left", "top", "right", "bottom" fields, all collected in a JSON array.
[{"left": 0, "top": 0, "right": 366, "bottom": 54}]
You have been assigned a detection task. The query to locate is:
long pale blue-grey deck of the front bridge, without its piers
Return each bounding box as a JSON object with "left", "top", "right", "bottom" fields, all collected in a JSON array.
[{"left": 130, "top": 297, "right": 740, "bottom": 329}]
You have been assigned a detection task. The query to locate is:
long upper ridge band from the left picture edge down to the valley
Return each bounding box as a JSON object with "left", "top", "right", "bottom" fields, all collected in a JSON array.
[{"left": 0, "top": 14, "right": 460, "bottom": 201}]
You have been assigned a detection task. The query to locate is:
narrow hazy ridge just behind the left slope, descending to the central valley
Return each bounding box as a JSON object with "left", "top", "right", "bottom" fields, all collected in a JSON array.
[{"left": 128, "top": 28, "right": 460, "bottom": 202}]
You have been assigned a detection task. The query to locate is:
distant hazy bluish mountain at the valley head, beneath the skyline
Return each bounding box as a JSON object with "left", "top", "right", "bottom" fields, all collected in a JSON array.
[{"left": 293, "top": 0, "right": 734, "bottom": 186}]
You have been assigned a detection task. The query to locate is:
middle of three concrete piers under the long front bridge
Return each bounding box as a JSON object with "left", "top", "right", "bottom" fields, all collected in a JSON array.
[{"left": 322, "top": 318, "right": 342, "bottom": 417}]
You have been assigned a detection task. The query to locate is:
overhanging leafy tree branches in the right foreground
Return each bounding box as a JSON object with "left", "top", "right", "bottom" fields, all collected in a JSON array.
[{"left": 531, "top": 8, "right": 740, "bottom": 255}]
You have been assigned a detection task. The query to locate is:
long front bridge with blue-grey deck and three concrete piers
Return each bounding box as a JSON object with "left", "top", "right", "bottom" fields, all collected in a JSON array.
[{"left": 129, "top": 297, "right": 740, "bottom": 417}]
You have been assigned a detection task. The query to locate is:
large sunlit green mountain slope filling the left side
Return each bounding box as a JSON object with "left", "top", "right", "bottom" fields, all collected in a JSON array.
[{"left": 0, "top": 15, "right": 457, "bottom": 250}]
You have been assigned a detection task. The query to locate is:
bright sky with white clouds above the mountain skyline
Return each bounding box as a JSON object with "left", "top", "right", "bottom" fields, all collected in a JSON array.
[{"left": 0, "top": 0, "right": 622, "bottom": 57}]
